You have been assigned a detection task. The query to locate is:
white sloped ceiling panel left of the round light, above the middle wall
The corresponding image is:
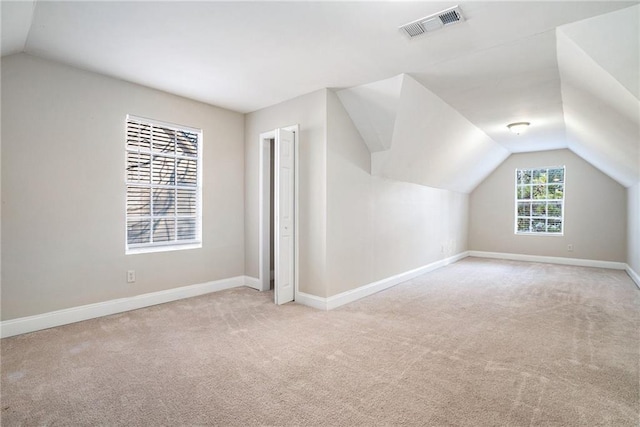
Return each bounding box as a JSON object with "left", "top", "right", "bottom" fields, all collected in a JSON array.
[{"left": 360, "top": 74, "right": 509, "bottom": 193}]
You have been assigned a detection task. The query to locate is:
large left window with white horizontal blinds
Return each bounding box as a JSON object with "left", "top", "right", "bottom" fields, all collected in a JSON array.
[{"left": 126, "top": 116, "right": 202, "bottom": 253}]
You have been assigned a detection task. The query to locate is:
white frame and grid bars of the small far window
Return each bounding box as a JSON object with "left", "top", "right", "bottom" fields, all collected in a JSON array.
[{"left": 513, "top": 165, "right": 567, "bottom": 237}]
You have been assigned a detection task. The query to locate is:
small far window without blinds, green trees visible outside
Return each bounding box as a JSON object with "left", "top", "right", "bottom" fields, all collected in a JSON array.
[{"left": 515, "top": 166, "right": 565, "bottom": 235}]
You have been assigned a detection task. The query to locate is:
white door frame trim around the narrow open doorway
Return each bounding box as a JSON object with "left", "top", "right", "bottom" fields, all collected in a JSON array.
[{"left": 258, "top": 125, "right": 300, "bottom": 301}]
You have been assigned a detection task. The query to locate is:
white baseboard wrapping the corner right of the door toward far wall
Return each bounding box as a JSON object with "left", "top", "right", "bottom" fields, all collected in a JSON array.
[{"left": 296, "top": 252, "right": 469, "bottom": 310}]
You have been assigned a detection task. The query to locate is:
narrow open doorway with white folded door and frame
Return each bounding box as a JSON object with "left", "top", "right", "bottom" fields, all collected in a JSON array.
[{"left": 259, "top": 125, "right": 298, "bottom": 304}]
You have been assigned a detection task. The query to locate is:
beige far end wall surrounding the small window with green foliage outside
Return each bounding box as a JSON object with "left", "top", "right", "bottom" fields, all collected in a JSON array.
[{"left": 469, "top": 150, "right": 627, "bottom": 262}]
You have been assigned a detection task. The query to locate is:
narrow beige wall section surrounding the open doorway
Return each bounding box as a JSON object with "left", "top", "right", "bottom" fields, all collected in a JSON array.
[{"left": 245, "top": 89, "right": 327, "bottom": 297}]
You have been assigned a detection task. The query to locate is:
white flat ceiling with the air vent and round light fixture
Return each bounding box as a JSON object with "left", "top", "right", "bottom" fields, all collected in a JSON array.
[{"left": 1, "top": 0, "right": 640, "bottom": 190}]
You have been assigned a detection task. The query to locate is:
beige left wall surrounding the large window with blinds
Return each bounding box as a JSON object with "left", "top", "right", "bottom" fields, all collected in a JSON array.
[{"left": 2, "top": 54, "right": 244, "bottom": 320}]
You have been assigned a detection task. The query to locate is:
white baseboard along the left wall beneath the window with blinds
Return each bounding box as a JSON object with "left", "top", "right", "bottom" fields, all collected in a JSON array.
[{"left": 0, "top": 276, "right": 252, "bottom": 338}]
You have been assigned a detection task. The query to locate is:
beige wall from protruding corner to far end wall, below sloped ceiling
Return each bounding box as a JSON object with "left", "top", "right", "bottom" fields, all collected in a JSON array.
[{"left": 326, "top": 91, "right": 468, "bottom": 296}]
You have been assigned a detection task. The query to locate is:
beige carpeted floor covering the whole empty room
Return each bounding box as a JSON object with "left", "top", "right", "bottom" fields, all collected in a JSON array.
[{"left": 1, "top": 258, "right": 640, "bottom": 426}]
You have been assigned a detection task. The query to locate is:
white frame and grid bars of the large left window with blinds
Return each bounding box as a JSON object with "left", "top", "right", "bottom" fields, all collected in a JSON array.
[{"left": 124, "top": 114, "right": 204, "bottom": 255}]
